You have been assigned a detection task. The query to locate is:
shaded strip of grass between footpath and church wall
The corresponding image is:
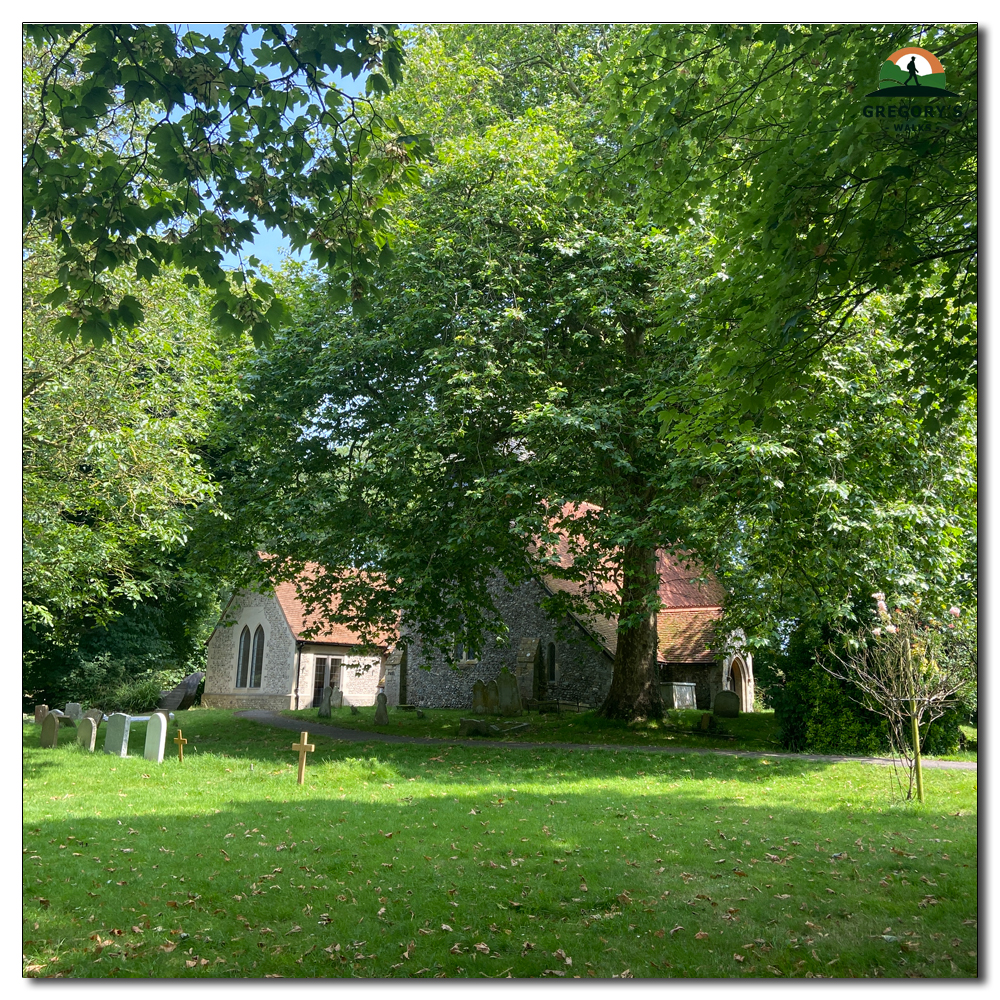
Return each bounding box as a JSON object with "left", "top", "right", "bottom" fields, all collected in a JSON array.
[{"left": 281, "top": 708, "right": 781, "bottom": 752}]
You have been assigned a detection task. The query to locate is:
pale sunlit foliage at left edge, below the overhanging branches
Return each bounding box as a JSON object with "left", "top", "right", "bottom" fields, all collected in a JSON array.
[{"left": 22, "top": 230, "right": 248, "bottom": 630}]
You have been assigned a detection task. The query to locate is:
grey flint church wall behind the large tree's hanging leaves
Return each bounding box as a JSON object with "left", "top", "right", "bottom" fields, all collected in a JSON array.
[{"left": 398, "top": 574, "right": 612, "bottom": 710}]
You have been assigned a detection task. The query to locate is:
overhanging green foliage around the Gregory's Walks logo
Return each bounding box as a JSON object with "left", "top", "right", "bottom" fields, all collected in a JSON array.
[{"left": 600, "top": 24, "right": 978, "bottom": 435}]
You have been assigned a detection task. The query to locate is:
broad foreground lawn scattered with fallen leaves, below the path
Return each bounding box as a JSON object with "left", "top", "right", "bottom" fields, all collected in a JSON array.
[{"left": 23, "top": 709, "right": 978, "bottom": 978}]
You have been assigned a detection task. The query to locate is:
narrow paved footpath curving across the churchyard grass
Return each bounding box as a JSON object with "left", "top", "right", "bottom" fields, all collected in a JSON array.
[{"left": 233, "top": 709, "right": 978, "bottom": 771}]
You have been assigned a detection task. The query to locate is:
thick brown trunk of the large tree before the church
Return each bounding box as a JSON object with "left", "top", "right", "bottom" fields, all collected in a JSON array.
[{"left": 599, "top": 545, "right": 663, "bottom": 721}]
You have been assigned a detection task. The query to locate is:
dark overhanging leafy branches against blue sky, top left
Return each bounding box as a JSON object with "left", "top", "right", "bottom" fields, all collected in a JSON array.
[{"left": 23, "top": 24, "right": 426, "bottom": 344}]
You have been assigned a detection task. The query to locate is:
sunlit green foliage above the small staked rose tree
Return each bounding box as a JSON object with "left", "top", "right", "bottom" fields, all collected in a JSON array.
[{"left": 686, "top": 308, "right": 978, "bottom": 651}]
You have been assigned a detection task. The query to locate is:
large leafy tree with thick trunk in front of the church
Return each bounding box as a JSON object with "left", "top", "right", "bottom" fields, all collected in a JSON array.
[{"left": 211, "top": 25, "right": 704, "bottom": 718}]
